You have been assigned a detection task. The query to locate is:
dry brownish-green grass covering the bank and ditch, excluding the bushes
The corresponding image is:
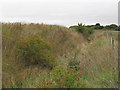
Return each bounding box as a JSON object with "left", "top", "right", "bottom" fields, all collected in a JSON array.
[{"left": 2, "top": 23, "right": 118, "bottom": 88}]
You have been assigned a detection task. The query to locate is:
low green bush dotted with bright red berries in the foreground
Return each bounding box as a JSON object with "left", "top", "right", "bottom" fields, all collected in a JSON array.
[{"left": 40, "top": 66, "right": 85, "bottom": 88}]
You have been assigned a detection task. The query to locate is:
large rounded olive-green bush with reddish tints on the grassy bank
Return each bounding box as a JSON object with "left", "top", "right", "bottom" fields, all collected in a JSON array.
[{"left": 17, "top": 34, "right": 55, "bottom": 67}]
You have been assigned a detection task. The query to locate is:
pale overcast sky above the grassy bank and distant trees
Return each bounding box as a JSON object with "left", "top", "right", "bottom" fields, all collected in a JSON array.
[{"left": 0, "top": 0, "right": 119, "bottom": 27}]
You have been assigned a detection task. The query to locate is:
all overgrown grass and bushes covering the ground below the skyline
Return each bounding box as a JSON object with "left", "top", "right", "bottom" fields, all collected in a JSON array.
[{"left": 2, "top": 23, "right": 118, "bottom": 88}]
